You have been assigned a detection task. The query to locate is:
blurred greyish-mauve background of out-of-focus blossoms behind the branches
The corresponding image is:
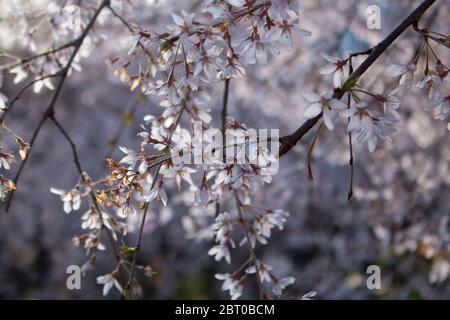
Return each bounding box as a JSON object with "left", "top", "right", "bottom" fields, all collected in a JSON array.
[{"left": 0, "top": 0, "right": 450, "bottom": 299}]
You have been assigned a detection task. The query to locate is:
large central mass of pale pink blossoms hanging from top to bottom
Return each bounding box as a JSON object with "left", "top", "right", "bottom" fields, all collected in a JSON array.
[{"left": 95, "top": 1, "right": 309, "bottom": 298}]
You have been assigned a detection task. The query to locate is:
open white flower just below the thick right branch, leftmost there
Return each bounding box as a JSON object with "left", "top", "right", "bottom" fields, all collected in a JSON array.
[{"left": 303, "top": 92, "right": 347, "bottom": 130}]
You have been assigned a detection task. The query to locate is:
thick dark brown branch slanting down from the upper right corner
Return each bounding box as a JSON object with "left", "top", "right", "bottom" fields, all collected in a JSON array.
[{"left": 279, "top": 0, "right": 436, "bottom": 157}]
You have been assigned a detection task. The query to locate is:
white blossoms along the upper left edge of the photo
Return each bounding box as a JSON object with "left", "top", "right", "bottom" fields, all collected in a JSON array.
[{"left": 0, "top": 2, "right": 101, "bottom": 201}]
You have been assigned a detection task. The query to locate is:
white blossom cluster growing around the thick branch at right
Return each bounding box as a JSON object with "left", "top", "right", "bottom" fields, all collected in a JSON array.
[{"left": 304, "top": 37, "right": 450, "bottom": 152}]
